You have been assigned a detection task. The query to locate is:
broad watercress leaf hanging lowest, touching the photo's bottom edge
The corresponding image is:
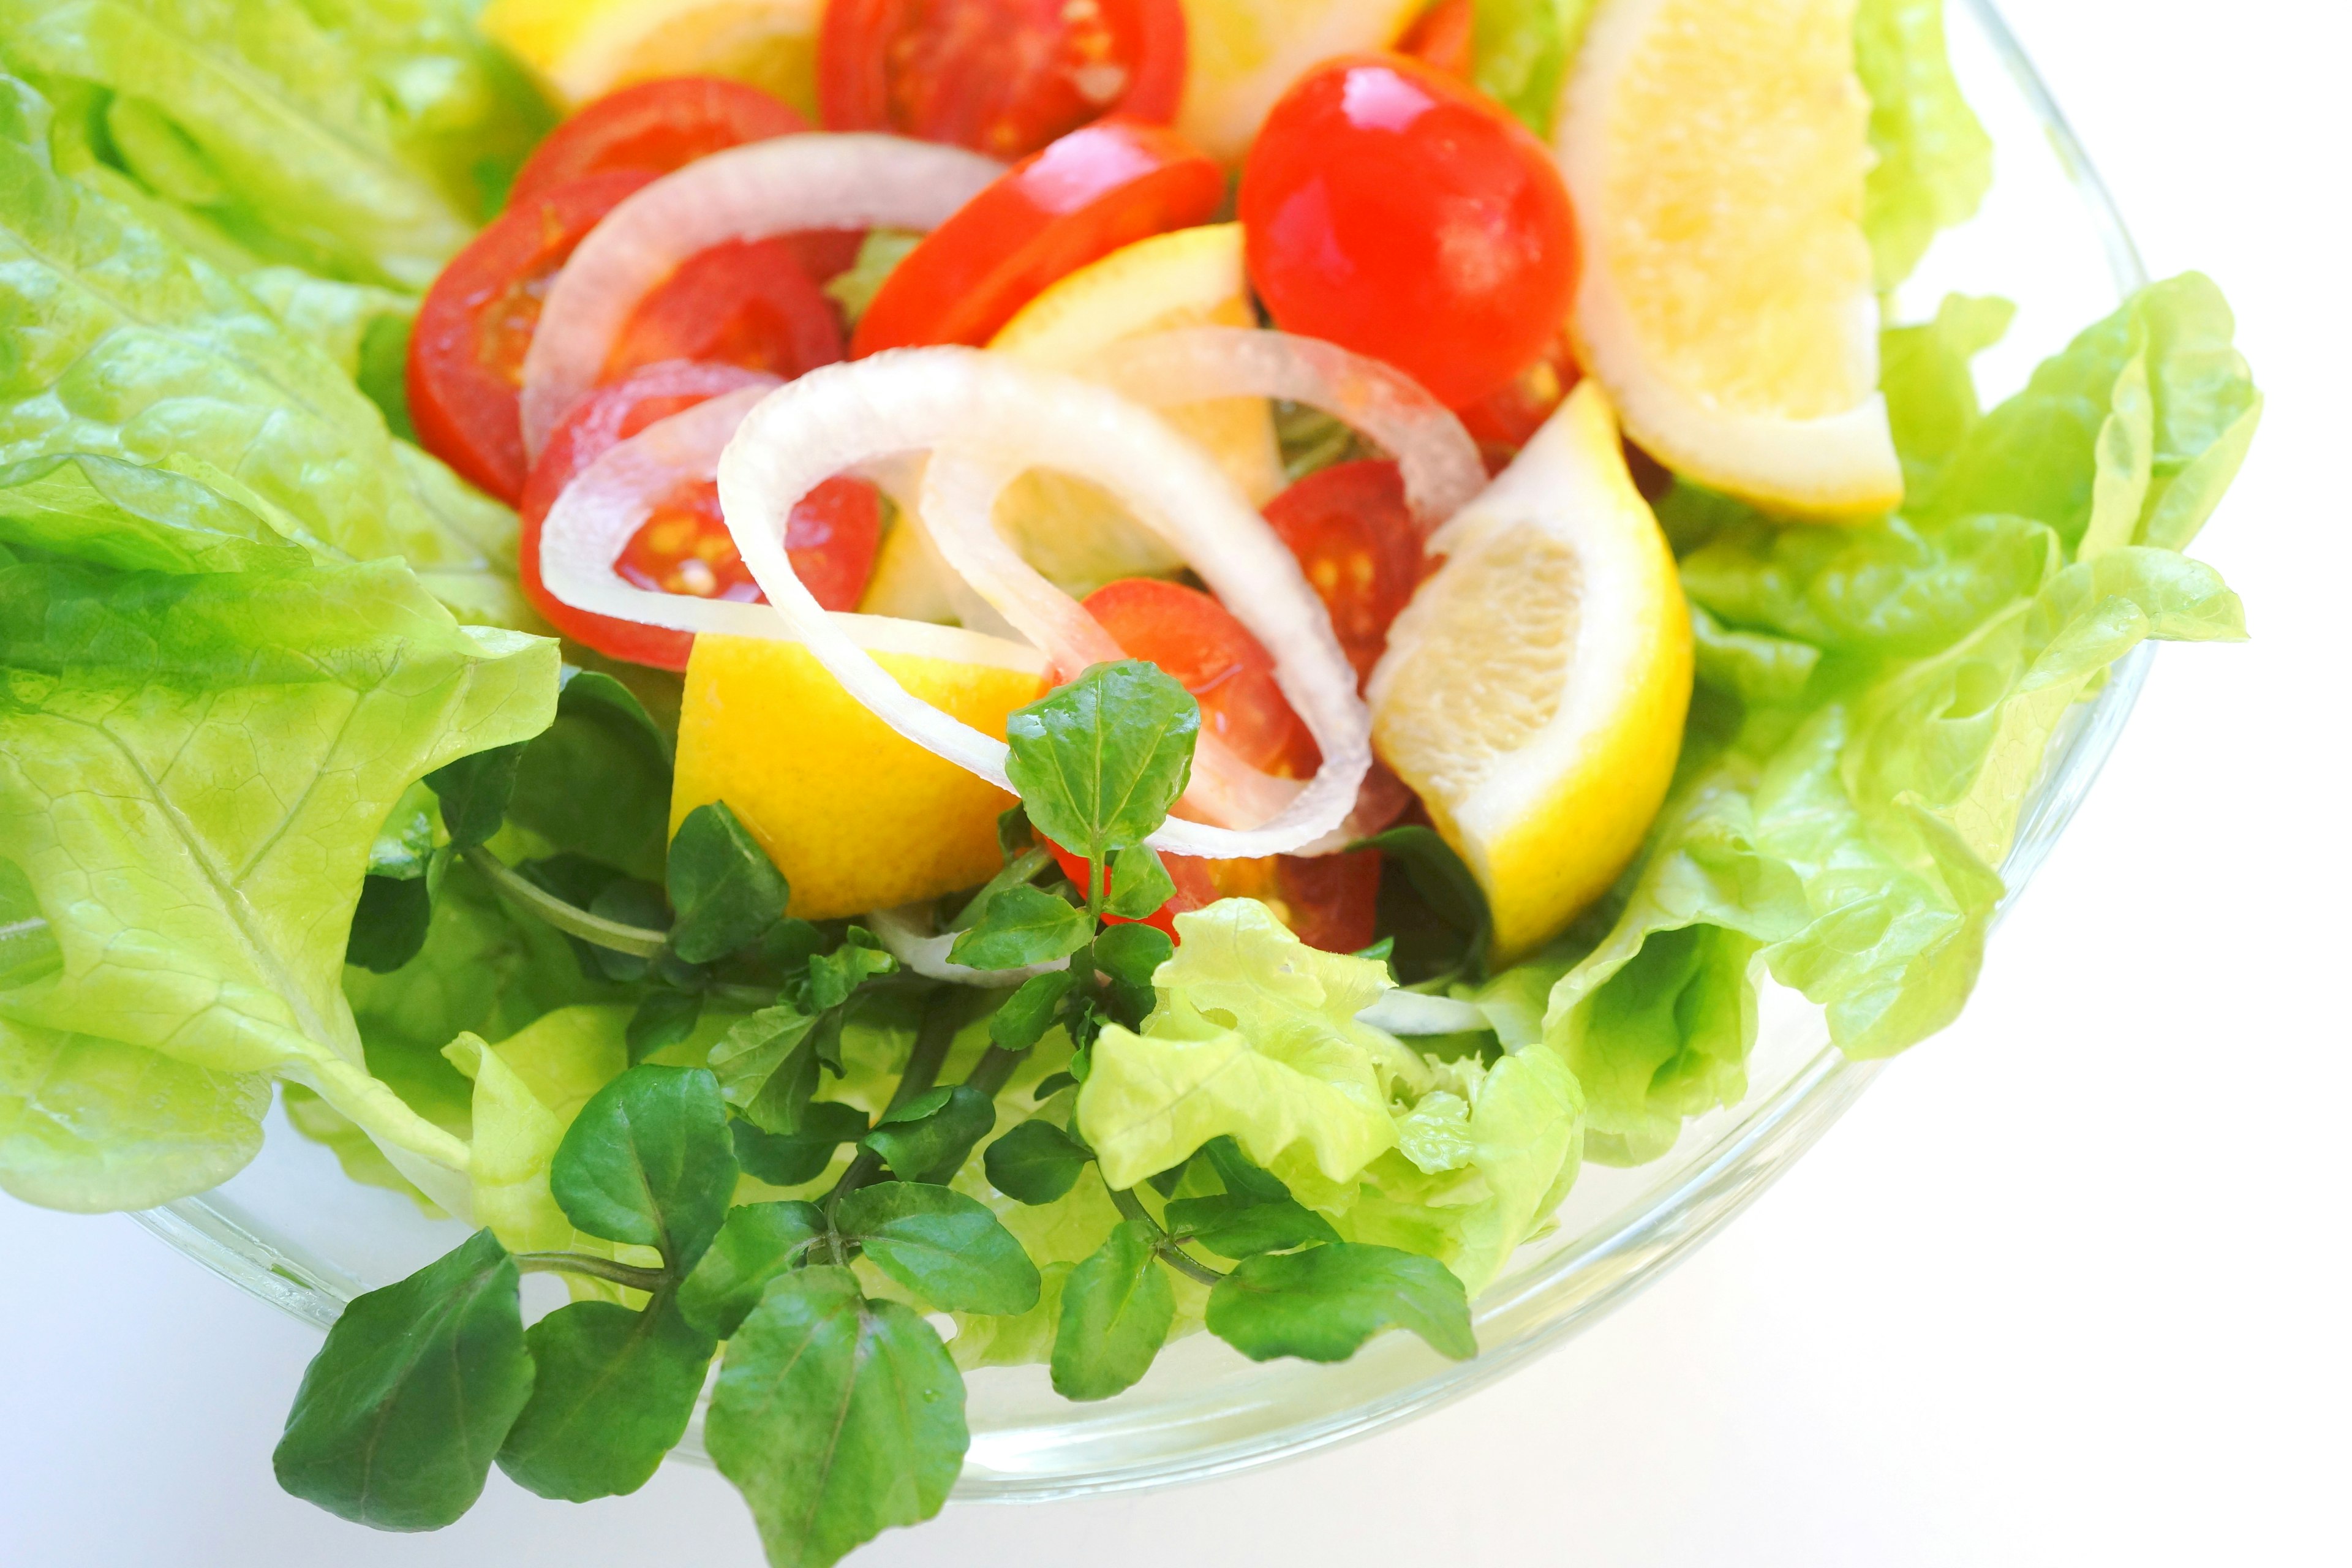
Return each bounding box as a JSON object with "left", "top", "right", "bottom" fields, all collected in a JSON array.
[{"left": 703, "top": 1267, "right": 971, "bottom": 1568}]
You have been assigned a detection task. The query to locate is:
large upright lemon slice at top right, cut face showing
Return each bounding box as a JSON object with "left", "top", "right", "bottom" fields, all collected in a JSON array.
[{"left": 1557, "top": 0, "right": 1903, "bottom": 519}]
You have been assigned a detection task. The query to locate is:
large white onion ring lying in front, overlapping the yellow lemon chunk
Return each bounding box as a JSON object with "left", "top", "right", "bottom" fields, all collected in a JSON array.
[{"left": 720, "top": 348, "right": 1371, "bottom": 861}]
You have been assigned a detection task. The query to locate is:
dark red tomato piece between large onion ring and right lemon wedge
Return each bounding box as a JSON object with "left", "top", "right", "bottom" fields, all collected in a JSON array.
[{"left": 1265, "top": 458, "right": 1420, "bottom": 684}]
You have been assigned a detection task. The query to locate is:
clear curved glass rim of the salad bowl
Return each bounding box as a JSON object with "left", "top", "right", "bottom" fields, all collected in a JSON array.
[{"left": 132, "top": 0, "right": 2154, "bottom": 1502}]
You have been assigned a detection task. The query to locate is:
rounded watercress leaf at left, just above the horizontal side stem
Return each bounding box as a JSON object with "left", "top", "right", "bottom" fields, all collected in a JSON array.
[{"left": 548, "top": 1063, "right": 736, "bottom": 1274}]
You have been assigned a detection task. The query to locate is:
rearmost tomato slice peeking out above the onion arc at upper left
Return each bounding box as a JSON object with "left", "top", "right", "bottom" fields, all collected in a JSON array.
[{"left": 508, "top": 75, "right": 809, "bottom": 207}]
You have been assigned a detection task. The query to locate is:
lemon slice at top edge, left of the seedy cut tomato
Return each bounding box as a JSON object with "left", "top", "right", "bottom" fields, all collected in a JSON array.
[{"left": 480, "top": 0, "right": 826, "bottom": 120}]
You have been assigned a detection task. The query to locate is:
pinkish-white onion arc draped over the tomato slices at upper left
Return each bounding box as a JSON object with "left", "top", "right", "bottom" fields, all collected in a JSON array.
[{"left": 522, "top": 132, "right": 1005, "bottom": 458}]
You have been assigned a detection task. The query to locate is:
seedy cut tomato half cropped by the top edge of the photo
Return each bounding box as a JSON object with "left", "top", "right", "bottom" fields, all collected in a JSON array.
[{"left": 816, "top": 0, "right": 1185, "bottom": 157}]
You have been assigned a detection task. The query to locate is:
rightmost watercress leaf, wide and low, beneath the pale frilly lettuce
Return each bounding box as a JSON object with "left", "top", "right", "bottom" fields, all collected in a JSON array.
[{"left": 1209, "top": 1242, "right": 1477, "bottom": 1361}]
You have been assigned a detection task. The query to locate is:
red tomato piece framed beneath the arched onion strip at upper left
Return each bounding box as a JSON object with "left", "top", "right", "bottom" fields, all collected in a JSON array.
[{"left": 602, "top": 235, "right": 842, "bottom": 381}]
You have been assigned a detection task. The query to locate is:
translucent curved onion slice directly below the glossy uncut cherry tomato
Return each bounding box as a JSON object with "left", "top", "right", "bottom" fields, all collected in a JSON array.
[{"left": 1091, "top": 324, "right": 1487, "bottom": 541}]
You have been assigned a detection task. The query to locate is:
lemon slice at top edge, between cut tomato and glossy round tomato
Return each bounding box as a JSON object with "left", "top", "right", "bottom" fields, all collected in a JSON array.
[{"left": 1176, "top": 0, "right": 1423, "bottom": 165}]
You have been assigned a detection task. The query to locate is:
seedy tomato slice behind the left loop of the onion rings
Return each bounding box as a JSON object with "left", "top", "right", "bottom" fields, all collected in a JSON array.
[{"left": 520, "top": 362, "right": 882, "bottom": 670}]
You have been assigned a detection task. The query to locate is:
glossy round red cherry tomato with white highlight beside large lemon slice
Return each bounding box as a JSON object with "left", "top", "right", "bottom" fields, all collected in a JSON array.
[{"left": 1240, "top": 54, "right": 1576, "bottom": 409}]
